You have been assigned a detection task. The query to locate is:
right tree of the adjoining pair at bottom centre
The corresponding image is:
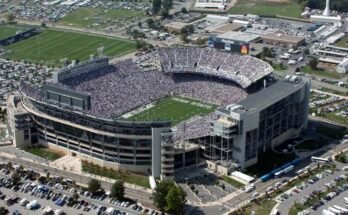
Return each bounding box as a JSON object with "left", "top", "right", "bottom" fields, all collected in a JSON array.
[{"left": 166, "top": 186, "right": 186, "bottom": 215}]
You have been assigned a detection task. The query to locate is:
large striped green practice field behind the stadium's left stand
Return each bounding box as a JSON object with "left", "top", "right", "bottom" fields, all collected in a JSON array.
[{"left": 5, "top": 30, "right": 136, "bottom": 65}]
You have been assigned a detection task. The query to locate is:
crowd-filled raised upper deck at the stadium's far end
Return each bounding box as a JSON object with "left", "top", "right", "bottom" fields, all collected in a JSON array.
[{"left": 158, "top": 48, "right": 273, "bottom": 88}]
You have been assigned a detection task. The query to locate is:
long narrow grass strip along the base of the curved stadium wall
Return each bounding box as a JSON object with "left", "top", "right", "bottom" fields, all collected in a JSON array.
[{"left": 82, "top": 161, "right": 151, "bottom": 188}]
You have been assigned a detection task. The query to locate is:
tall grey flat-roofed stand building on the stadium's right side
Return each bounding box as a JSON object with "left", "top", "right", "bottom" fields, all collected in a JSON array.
[{"left": 206, "top": 76, "right": 310, "bottom": 169}]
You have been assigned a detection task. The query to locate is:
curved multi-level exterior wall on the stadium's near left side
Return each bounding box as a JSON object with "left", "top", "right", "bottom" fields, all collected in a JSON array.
[{"left": 9, "top": 95, "right": 174, "bottom": 176}]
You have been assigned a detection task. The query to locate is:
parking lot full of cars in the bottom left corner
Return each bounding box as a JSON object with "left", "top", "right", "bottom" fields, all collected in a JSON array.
[{"left": 0, "top": 164, "right": 150, "bottom": 215}]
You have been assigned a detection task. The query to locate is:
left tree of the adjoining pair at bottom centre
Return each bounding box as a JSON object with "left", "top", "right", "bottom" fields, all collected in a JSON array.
[{"left": 152, "top": 181, "right": 175, "bottom": 210}]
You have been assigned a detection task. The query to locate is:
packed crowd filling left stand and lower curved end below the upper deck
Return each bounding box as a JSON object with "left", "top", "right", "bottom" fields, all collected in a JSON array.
[{"left": 22, "top": 60, "right": 247, "bottom": 121}]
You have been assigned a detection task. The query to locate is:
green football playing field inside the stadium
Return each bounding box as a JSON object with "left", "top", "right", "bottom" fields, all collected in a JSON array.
[{"left": 128, "top": 97, "right": 217, "bottom": 125}]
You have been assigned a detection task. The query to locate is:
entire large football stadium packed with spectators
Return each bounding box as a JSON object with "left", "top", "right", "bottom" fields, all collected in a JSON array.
[{"left": 7, "top": 48, "right": 309, "bottom": 178}]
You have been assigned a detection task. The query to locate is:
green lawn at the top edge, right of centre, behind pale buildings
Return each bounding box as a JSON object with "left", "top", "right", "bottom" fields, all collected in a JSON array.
[{"left": 228, "top": 0, "right": 302, "bottom": 18}]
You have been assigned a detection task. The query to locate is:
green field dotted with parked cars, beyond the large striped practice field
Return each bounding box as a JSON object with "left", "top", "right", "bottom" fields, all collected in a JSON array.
[{"left": 58, "top": 7, "right": 146, "bottom": 27}]
